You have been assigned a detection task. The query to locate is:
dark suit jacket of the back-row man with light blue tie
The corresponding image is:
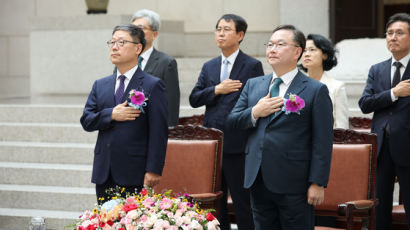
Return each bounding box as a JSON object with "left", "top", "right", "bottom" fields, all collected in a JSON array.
[{"left": 189, "top": 51, "right": 263, "bottom": 153}]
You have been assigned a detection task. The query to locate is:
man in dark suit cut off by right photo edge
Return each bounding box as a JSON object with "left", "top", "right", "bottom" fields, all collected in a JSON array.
[{"left": 359, "top": 13, "right": 410, "bottom": 230}]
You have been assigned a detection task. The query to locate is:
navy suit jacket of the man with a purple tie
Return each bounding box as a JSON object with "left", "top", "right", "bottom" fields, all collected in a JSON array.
[{"left": 81, "top": 68, "right": 168, "bottom": 186}]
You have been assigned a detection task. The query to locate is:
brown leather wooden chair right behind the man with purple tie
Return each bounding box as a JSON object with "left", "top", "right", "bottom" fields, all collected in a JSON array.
[{"left": 154, "top": 125, "right": 223, "bottom": 215}]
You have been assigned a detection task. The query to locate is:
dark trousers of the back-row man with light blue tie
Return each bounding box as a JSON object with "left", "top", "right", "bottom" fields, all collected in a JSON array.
[{"left": 218, "top": 153, "right": 254, "bottom": 230}]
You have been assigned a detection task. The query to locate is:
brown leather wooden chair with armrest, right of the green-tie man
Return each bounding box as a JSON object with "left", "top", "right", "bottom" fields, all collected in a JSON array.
[{"left": 315, "top": 129, "right": 378, "bottom": 230}]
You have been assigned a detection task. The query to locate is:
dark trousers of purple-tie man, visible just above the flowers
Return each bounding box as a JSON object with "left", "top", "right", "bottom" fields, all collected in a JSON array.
[{"left": 95, "top": 172, "right": 142, "bottom": 204}]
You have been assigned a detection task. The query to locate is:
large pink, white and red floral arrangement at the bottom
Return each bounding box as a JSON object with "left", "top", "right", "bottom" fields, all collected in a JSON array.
[{"left": 75, "top": 188, "right": 219, "bottom": 230}]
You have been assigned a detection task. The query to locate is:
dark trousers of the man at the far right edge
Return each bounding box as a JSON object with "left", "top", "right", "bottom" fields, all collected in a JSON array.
[{"left": 376, "top": 136, "right": 410, "bottom": 230}]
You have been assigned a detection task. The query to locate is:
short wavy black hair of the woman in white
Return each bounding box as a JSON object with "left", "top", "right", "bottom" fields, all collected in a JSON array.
[{"left": 300, "top": 34, "right": 337, "bottom": 71}]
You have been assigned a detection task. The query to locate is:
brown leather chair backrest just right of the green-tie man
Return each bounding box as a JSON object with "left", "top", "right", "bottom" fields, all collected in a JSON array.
[{"left": 315, "top": 129, "right": 377, "bottom": 215}]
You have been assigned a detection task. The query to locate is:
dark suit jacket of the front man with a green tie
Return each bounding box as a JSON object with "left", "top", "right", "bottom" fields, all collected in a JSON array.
[{"left": 227, "top": 72, "right": 333, "bottom": 194}]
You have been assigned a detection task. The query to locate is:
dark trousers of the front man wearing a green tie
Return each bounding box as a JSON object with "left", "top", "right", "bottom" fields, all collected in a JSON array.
[{"left": 251, "top": 172, "right": 315, "bottom": 230}]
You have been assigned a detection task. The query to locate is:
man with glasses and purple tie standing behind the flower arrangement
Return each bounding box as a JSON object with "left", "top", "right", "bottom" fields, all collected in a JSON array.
[{"left": 81, "top": 24, "right": 168, "bottom": 203}]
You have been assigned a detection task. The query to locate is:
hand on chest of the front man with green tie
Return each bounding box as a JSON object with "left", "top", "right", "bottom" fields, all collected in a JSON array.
[{"left": 252, "top": 94, "right": 283, "bottom": 119}]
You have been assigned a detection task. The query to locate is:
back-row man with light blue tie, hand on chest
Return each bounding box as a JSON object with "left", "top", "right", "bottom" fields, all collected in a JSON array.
[{"left": 189, "top": 14, "right": 263, "bottom": 230}]
